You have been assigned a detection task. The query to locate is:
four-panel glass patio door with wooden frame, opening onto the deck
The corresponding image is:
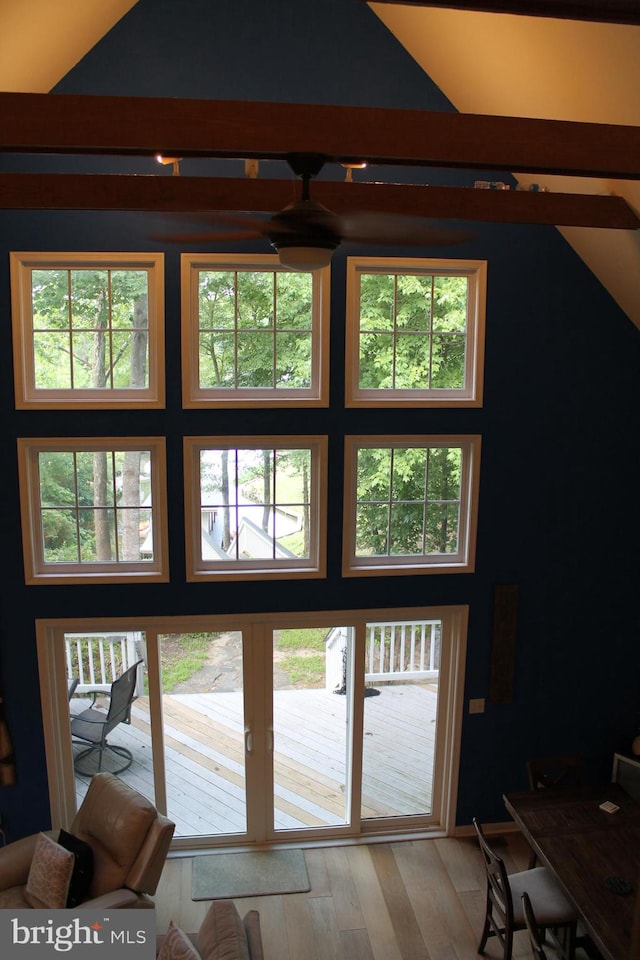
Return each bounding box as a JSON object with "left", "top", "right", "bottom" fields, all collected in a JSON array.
[{"left": 38, "top": 607, "right": 466, "bottom": 849}]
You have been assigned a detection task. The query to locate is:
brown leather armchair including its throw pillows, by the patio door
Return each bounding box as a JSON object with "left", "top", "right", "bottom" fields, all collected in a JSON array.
[{"left": 0, "top": 773, "right": 175, "bottom": 909}]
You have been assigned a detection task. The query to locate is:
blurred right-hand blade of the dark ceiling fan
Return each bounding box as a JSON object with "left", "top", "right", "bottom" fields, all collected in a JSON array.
[{"left": 340, "top": 211, "right": 473, "bottom": 247}]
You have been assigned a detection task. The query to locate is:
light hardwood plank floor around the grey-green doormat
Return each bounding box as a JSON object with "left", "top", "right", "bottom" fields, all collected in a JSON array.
[{"left": 155, "top": 834, "right": 592, "bottom": 960}]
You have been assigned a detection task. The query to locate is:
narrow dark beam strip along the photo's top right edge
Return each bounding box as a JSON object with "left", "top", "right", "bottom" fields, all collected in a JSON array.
[{"left": 361, "top": 0, "right": 640, "bottom": 24}]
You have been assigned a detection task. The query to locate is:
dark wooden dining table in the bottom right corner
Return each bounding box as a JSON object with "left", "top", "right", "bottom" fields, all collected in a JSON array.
[{"left": 504, "top": 783, "right": 640, "bottom": 960}]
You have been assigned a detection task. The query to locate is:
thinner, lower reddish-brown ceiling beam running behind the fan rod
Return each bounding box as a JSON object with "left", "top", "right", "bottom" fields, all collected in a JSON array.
[{"left": 0, "top": 173, "right": 640, "bottom": 230}]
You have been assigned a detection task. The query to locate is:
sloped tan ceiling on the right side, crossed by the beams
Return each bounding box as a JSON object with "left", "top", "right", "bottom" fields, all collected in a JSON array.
[{"left": 369, "top": 2, "right": 640, "bottom": 327}]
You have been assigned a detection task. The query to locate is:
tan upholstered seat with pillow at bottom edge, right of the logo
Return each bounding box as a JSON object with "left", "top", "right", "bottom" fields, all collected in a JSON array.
[{"left": 156, "top": 900, "right": 264, "bottom": 960}]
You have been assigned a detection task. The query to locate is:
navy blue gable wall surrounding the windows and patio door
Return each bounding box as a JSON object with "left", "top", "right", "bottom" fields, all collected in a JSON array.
[{"left": 0, "top": 0, "right": 640, "bottom": 839}]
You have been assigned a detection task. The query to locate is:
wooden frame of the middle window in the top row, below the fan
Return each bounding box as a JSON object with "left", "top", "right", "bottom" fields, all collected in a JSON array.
[{"left": 181, "top": 253, "right": 330, "bottom": 409}]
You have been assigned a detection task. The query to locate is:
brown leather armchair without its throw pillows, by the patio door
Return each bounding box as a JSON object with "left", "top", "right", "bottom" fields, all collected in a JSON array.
[{"left": 0, "top": 773, "right": 175, "bottom": 909}]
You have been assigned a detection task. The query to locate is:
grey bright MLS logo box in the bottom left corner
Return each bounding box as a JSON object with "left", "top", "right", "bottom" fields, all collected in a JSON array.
[{"left": 0, "top": 909, "right": 156, "bottom": 960}]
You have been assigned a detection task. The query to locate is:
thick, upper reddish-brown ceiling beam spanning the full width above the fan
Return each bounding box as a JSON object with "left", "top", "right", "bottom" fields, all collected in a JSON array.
[{"left": 0, "top": 93, "right": 640, "bottom": 180}]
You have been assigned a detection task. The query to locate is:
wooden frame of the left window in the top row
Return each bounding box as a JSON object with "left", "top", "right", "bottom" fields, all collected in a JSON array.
[{"left": 9, "top": 252, "right": 165, "bottom": 410}]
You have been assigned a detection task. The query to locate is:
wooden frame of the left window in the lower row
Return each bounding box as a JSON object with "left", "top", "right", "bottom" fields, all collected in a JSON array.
[{"left": 17, "top": 437, "right": 169, "bottom": 584}]
